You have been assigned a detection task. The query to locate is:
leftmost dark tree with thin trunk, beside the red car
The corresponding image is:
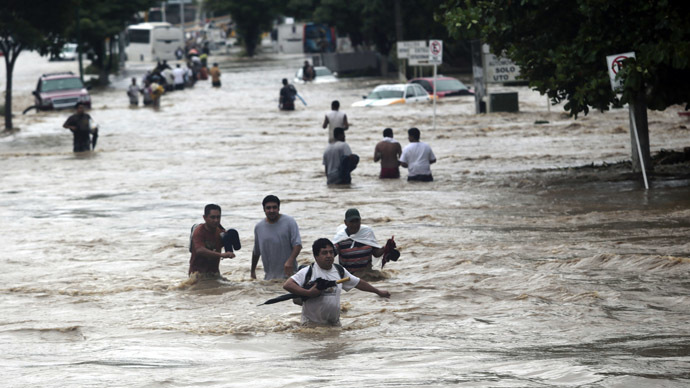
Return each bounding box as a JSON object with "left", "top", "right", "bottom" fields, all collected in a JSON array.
[{"left": 0, "top": 0, "right": 72, "bottom": 129}]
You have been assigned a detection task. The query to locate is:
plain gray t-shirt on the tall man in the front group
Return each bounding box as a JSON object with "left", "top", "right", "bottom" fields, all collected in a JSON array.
[{"left": 254, "top": 214, "right": 302, "bottom": 280}]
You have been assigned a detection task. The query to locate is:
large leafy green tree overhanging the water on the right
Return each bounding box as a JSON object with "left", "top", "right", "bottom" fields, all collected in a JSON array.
[{"left": 438, "top": 0, "right": 690, "bottom": 171}]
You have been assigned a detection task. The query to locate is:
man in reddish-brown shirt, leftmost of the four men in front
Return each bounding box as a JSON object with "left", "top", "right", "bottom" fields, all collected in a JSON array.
[{"left": 189, "top": 204, "right": 235, "bottom": 276}]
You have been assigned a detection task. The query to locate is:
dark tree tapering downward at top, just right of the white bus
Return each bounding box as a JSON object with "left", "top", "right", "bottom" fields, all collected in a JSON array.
[{"left": 204, "top": 0, "right": 284, "bottom": 57}]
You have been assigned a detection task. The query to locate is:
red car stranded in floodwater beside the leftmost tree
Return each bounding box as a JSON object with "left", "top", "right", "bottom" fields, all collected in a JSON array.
[{"left": 32, "top": 71, "right": 91, "bottom": 110}]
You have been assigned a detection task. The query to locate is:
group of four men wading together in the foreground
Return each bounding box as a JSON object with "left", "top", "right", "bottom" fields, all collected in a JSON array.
[{"left": 189, "top": 195, "right": 400, "bottom": 325}]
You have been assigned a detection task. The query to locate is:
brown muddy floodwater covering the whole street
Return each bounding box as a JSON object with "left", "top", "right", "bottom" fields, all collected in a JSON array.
[{"left": 0, "top": 53, "right": 690, "bottom": 388}]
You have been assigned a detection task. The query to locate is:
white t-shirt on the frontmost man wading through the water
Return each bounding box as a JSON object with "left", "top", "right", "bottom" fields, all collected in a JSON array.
[{"left": 292, "top": 263, "right": 359, "bottom": 326}]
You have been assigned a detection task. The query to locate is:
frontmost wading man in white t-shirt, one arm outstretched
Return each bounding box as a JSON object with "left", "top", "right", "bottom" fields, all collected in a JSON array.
[{"left": 283, "top": 238, "right": 391, "bottom": 326}]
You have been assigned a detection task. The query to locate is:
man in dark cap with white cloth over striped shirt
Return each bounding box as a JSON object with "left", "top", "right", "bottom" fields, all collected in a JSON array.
[{"left": 333, "top": 209, "right": 384, "bottom": 273}]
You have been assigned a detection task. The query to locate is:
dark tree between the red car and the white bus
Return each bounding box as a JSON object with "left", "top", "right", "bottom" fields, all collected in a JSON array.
[{"left": 69, "top": 0, "right": 160, "bottom": 85}]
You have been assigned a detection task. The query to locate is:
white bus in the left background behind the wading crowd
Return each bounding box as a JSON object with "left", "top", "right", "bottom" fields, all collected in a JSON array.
[{"left": 125, "top": 22, "right": 184, "bottom": 62}]
